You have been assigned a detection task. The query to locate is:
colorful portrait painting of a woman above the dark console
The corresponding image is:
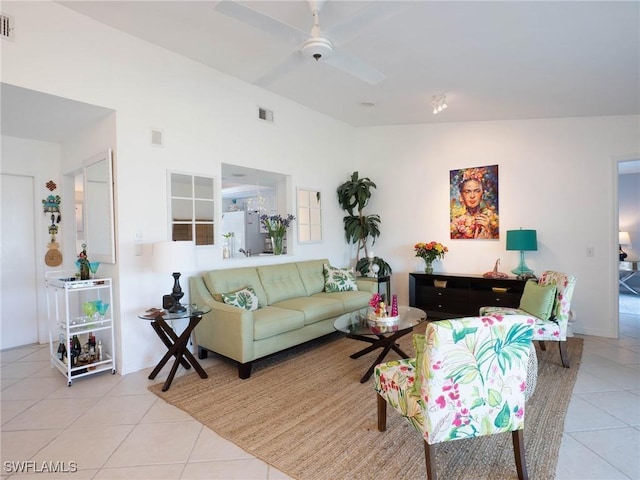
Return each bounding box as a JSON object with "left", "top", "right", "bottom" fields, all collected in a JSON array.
[{"left": 449, "top": 165, "right": 500, "bottom": 239}]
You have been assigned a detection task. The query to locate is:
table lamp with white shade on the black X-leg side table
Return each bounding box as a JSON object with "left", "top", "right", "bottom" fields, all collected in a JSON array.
[{"left": 153, "top": 241, "right": 198, "bottom": 313}]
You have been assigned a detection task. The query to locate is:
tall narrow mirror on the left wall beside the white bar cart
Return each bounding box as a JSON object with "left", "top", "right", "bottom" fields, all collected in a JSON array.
[{"left": 82, "top": 149, "right": 116, "bottom": 263}]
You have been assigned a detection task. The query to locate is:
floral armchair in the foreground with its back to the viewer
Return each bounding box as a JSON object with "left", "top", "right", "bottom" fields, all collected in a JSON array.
[{"left": 374, "top": 315, "right": 534, "bottom": 480}]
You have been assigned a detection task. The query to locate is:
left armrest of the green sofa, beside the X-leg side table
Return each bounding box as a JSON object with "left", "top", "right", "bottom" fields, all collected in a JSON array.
[{"left": 189, "top": 277, "right": 254, "bottom": 363}]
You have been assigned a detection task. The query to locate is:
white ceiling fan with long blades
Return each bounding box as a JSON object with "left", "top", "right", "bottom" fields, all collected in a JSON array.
[{"left": 215, "top": 0, "right": 401, "bottom": 86}]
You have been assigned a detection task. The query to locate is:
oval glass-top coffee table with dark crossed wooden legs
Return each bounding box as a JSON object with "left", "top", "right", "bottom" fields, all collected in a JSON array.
[{"left": 333, "top": 306, "right": 427, "bottom": 383}]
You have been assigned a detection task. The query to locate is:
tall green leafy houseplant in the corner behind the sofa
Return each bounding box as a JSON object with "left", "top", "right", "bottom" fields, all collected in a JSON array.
[{"left": 337, "top": 172, "right": 391, "bottom": 276}]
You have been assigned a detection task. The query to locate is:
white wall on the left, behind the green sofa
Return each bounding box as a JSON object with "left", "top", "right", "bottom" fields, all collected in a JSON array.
[{"left": 2, "top": 2, "right": 354, "bottom": 373}]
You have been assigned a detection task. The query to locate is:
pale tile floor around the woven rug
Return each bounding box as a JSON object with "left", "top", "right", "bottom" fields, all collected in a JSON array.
[{"left": 0, "top": 297, "right": 640, "bottom": 480}]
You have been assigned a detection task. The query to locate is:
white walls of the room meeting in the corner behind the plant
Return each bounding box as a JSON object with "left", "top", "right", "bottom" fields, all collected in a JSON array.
[{"left": 1, "top": 2, "right": 640, "bottom": 373}]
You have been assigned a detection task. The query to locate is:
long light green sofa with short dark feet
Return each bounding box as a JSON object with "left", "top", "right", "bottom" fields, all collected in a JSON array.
[{"left": 189, "top": 259, "right": 378, "bottom": 379}]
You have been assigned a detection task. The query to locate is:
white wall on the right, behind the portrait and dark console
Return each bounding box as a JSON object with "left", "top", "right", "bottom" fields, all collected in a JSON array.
[{"left": 358, "top": 116, "right": 640, "bottom": 337}]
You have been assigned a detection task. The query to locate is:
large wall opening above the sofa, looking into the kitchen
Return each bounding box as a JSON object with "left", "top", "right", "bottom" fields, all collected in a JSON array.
[{"left": 219, "top": 163, "right": 291, "bottom": 258}]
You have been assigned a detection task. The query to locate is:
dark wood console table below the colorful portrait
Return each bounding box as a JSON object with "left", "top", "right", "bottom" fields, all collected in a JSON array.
[{"left": 409, "top": 272, "right": 526, "bottom": 319}]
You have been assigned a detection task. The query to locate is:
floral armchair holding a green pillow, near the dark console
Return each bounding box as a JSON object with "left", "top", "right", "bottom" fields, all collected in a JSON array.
[{"left": 480, "top": 270, "right": 576, "bottom": 368}]
